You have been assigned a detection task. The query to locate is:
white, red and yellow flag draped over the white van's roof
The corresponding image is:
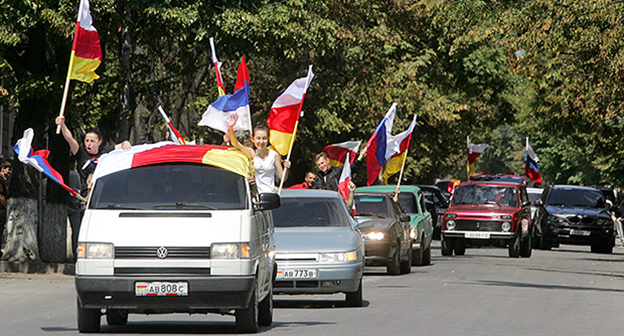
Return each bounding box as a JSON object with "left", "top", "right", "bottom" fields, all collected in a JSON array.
[{"left": 93, "top": 141, "right": 254, "bottom": 181}]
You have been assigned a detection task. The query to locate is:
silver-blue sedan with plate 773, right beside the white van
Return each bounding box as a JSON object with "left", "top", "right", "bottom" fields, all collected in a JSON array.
[{"left": 273, "top": 190, "right": 366, "bottom": 307}]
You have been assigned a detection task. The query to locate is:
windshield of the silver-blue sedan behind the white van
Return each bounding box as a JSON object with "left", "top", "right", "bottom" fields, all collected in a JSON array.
[{"left": 273, "top": 197, "right": 351, "bottom": 227}]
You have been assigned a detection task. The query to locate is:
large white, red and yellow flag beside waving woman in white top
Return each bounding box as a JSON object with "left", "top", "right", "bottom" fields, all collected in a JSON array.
[{"left": 267, "top": 65, "right": 314, "bottom": 155}]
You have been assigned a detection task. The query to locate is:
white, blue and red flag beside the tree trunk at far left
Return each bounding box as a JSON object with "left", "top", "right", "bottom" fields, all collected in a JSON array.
[{"left": 13, "top": 128, "right": 79, "bottom": 197}]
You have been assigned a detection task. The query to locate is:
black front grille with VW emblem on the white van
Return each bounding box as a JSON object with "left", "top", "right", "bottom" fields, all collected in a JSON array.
[{"left": 115, "top": 246, "right": 210, "bottom": 259}]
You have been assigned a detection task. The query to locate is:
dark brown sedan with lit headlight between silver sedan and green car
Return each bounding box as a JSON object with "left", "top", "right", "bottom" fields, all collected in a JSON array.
[{"left": 354, "top": 192, "right": 415, "bottom": 275}]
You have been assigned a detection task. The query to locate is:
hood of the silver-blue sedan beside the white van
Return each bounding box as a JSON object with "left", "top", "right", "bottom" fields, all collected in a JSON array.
[{"left": 275, "top": 227, "right": 362, "bottom": 253}]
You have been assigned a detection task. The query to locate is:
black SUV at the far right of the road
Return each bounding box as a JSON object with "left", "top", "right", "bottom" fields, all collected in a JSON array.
[{"left": 533, "top": 185, "right": 615, "bottom": 253}]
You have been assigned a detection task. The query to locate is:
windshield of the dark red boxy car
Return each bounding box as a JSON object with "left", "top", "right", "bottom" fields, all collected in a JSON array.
[{"left": 453, "top": 184, "right": 518, "bottom": 207}]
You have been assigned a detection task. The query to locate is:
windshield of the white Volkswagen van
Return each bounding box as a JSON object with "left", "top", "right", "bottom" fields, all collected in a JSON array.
[{"left": 89, "top": 164, "right": 248, "bottom": 210}]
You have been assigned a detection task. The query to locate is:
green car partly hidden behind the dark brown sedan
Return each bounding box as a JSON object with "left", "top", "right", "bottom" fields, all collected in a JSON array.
[{"left": 355, "top": 185, "right": 433, "bottom": 266}]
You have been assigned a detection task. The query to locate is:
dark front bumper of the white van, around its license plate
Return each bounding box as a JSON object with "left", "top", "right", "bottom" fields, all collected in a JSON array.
[{"left": 76, "top": 276, "right": 256, "bottom": 314}]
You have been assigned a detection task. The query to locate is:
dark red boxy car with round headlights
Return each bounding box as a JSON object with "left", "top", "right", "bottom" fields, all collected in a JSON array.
[{"left": 441, "top": 181, "right": 532, "bottom": 258}]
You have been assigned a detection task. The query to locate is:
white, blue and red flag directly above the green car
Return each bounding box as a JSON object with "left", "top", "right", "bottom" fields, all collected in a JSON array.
[{"left": 366, "top": 103, "right": 400, "bottom": 185}]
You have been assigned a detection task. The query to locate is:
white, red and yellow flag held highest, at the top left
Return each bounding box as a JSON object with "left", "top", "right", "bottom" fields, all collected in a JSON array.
[{"left": 67, "top": 0, "right": 102, "bottom": 83}]
